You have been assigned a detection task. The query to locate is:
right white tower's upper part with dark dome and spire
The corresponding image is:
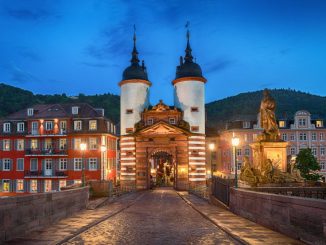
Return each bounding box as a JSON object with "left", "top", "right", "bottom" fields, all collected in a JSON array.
[{"left": 172, "top": 30, "right": 206, "bottom": 134}]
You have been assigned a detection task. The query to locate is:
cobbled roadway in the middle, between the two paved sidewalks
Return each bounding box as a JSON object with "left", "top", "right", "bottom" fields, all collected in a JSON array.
[{"left": 65, "top": 188, "right": 238, "bottom": 245}]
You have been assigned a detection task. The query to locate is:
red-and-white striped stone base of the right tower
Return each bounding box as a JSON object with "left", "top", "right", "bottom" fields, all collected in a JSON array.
[{"left": 188, "top": 135, "right": 206, "bottom": 185}]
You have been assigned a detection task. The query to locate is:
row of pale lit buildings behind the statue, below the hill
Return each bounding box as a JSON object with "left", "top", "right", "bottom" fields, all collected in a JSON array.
[{"left": 209, "top": 110, "right": 326, "bottom": 179}]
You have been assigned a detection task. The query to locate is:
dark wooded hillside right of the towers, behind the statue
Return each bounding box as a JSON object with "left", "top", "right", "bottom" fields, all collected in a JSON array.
[{"left": 206, "top": 89, "right": 326, "bottom": 126}]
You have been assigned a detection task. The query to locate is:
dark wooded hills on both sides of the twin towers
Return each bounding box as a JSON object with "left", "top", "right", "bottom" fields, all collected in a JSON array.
[{"left": 0, "top": 83, "right": 326, "bottom": 127}]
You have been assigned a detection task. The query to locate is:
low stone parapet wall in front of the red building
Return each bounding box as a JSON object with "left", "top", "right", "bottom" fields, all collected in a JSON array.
[{"left": 0, "top": 187, "right": 89, "bottom": 243}]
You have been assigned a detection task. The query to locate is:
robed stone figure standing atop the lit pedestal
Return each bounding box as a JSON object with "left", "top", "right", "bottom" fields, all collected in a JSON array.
[{"left": 260, "top": 89, "right": 280, "bottom": 141}]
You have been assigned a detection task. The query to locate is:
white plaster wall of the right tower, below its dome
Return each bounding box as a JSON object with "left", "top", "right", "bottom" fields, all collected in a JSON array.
[{"left": 174, "top": 80, "right": 205, "bottom": 134}]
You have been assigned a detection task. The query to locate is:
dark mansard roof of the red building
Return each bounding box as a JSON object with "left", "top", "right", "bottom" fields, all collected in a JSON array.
[{"left": 5, "top": 103, "right": 103, "bottom": 120}]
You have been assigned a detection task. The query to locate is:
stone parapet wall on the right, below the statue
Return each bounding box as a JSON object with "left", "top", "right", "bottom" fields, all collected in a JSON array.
[{"left": 229, "top": 188, "right": 326, "bottom": 244}]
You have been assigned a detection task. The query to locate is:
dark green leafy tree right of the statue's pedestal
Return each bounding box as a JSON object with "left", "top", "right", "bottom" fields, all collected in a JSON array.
[{"left": 295, "top": 148, "right": 321, "bottom": 181}]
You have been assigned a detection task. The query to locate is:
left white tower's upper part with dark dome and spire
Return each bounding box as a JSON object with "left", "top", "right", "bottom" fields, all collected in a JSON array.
[{"left": 119, "top": 33, "right": 152, "bottom": 135}]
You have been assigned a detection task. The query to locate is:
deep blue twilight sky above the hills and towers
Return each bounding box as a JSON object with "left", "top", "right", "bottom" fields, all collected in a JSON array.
[{"left": 0, "top": 0, "right": 326, "bottom": 104}]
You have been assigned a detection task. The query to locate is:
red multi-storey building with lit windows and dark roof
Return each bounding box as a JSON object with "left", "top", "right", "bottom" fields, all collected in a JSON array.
[{"left": 0, "top": 103, "right": 117, "bottom": 193}]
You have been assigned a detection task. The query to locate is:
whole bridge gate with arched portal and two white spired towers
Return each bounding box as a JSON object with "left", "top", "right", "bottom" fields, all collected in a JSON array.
[{"left": 119, "top": 28, "right": 206, "bottom": 190}]
